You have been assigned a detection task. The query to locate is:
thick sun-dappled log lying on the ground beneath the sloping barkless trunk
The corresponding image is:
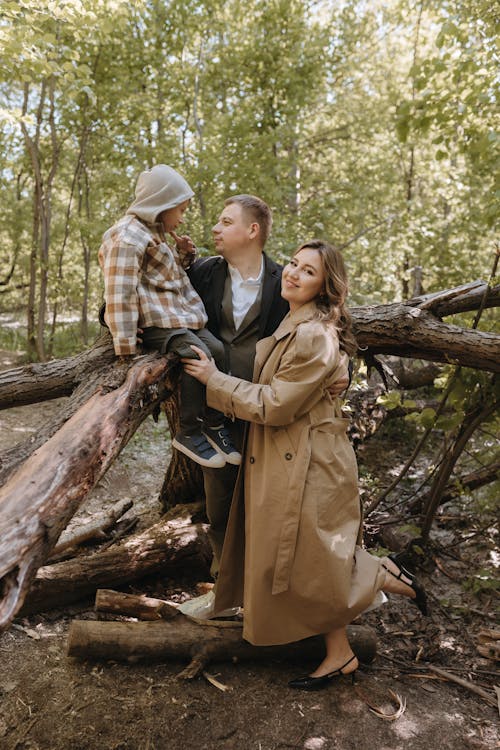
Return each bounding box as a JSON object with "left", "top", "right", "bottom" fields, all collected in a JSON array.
[{"left": 20, "top": 504, "right": 212, "bottom": 615}]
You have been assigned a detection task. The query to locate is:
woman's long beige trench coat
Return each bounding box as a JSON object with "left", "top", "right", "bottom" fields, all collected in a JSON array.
[{"left": 207, "top": 303, "right": 384, "bottom": 646}]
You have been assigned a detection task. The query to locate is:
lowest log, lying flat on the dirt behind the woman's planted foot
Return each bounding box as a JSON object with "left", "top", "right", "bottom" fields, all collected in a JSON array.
[{"left": 66, "top": 616, "right": 377, "bottom": 679}]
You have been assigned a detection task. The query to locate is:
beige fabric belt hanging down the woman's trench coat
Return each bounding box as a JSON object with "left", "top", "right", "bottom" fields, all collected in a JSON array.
[{"left": 271, "top": 417, "right": 349, "bottom": 594}]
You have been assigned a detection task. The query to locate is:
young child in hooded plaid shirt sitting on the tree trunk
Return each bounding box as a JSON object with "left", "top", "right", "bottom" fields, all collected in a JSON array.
[{"left": 99, "top": 164, "right": 241, "bottom": 468}]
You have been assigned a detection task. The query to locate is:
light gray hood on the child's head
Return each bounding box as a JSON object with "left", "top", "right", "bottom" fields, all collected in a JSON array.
[{"left": 127, "top": 164, "right": 194, "bottom": 224}]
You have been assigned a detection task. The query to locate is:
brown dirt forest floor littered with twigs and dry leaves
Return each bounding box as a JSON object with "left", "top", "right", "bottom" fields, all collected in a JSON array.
[{"left": 0, "top": 353, "right": 500, "bottom": 750}]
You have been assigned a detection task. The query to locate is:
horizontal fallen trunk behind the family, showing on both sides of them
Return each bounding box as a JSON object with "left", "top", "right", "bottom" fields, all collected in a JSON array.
[{"left": 0, "top": 281, "right": 500, "bottom": 408}]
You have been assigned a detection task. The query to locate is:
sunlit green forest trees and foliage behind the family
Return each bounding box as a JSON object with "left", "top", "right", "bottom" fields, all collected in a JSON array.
[{"left": 0, "top": 0, "right": 499, "bottom": 360}]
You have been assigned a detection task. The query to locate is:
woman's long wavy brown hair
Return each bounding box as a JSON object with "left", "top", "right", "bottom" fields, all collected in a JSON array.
[{"left": 294, "top": 240, "right": 358, "bottom": 357}]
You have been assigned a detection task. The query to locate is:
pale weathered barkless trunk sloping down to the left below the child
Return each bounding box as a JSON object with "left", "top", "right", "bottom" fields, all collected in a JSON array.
[{"left": 0, "top": 358, "right": 172, "bottom": 631}]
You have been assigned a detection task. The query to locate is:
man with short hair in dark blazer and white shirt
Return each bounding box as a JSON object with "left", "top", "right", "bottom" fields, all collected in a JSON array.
[{"left": 180, "top": 194, "right": 348, "bottom": 618}]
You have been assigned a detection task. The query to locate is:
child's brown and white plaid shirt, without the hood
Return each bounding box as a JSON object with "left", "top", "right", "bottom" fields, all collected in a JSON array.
[{"left": 99, "top": 215, "right": 207, "bottom": 355}]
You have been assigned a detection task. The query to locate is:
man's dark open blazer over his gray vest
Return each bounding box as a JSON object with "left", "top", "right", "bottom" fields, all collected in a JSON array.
[{"left": 188, "top": 253, "right": 289, "bottom": 339}]
